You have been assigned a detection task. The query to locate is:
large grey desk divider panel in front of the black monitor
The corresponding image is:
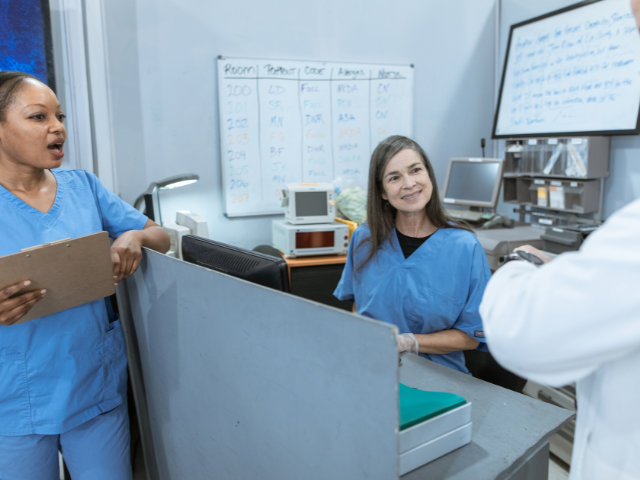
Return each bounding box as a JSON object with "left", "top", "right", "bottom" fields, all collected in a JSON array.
[{"left": 118, "top": 250, "right": 399, "bottom": 480}]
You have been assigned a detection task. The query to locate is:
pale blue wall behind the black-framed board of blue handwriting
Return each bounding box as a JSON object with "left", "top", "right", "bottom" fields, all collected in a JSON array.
[{"left": 496, "top": 0, "right": 640, "bottom": 219}]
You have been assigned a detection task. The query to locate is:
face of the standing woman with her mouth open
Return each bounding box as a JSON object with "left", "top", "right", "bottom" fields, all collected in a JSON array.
[{"left": 0, "top": 79, "right": 67, "bottom": 169}]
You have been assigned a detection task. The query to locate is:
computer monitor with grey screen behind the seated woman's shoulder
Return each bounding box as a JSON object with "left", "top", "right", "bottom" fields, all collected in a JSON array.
[{"left": 442, "top": 158, "right": 503, "bottom": 208}]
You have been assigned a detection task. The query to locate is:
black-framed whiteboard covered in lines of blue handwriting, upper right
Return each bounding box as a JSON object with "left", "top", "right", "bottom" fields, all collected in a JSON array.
[{"left": 493, "top": 0, "right": 640, "bottom": 138}]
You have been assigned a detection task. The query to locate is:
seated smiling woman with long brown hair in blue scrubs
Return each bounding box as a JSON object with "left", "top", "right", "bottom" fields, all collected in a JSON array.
[{"left": 334, "top": 136, "right": 491, "bottom": 373}]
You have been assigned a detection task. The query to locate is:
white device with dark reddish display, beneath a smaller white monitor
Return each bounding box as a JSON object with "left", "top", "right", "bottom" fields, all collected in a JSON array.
[{"left": 272, "top": 220, "right": 349, "bottom": 258}]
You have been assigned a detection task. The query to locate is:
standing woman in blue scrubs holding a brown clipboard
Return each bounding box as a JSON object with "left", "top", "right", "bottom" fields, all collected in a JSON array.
[{"left": 0, "top": 71, "right": 169, "bottom": 480}]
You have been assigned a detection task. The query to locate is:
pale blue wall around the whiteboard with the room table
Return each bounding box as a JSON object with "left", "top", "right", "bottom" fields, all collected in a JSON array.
[{"left": 104, "top": 0, "right": 496, "bottom": 248}]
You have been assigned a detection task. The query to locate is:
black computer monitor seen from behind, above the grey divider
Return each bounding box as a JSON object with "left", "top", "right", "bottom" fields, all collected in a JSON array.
[{"left": 182, "top": 235, "right": 289, "bottom": 292}]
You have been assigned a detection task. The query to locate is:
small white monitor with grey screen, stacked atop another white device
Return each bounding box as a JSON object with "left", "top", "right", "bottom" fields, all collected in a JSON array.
[{"left": 280, "top": 183, "right": 336, "bottom": 225}]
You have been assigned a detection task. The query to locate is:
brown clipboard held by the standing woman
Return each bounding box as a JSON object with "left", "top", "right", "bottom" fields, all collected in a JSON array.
[{"left": 0, "top": 232, "right": 115, "bottom": 324}]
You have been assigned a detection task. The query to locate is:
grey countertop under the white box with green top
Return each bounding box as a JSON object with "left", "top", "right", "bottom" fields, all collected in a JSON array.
[{"left": 400, "top": 354, "right": 574, "bottom": 480}]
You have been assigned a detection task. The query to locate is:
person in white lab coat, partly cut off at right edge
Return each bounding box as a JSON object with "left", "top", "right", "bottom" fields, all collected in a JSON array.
[{"left": 480, "top": 5, "right": 640, "bottom": 480}]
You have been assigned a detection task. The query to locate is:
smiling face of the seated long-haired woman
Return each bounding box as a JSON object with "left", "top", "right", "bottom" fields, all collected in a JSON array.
[{"left": 381, "top": 148, "right": 433, "bottom": 214}]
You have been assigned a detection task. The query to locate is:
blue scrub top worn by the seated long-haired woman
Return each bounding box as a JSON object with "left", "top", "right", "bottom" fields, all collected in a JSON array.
[{"left": 334, "top": 224, "right": 491, "bottom": 373}]
